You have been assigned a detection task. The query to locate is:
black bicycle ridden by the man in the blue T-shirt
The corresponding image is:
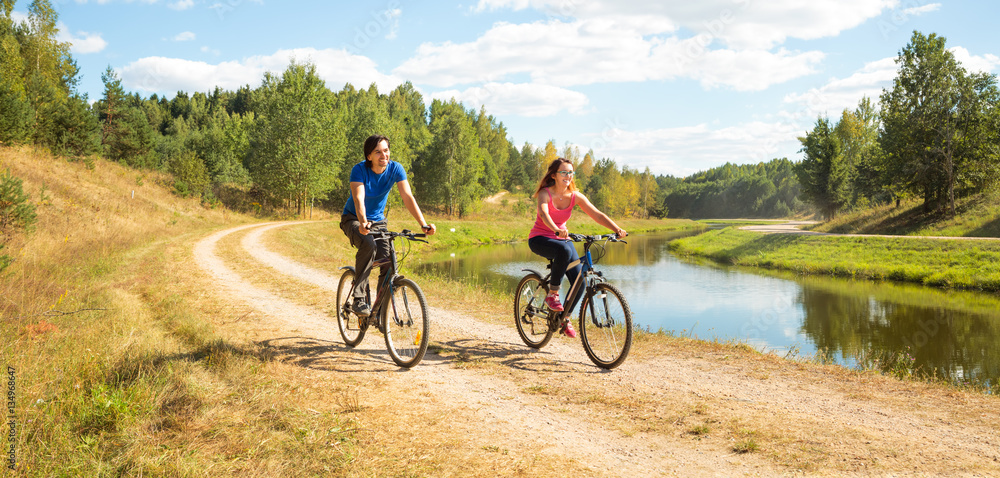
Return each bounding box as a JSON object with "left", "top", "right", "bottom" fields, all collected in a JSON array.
[{"left": 337, "top": 229, "right": 430, "bottom": 368}]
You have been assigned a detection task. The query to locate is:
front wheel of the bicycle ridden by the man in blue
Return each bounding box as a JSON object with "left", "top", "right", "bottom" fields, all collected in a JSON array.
[{"left": 382, "top": 278, "right": 430, "bottom": 368}]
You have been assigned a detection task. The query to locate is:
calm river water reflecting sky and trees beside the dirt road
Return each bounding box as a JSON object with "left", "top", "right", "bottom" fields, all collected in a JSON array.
[{"left": 418, "top": 232, "right": 1000, "bottom": 383}]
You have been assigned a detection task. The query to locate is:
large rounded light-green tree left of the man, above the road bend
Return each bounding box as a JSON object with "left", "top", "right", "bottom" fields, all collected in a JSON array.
[{"left": 247, "top": 61, "right": 345, "bottom": 214}]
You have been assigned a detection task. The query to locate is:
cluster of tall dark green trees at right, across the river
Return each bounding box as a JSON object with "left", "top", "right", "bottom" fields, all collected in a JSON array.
[{"left": 796, "top": 32, "right": 1000, "bottom": 218}]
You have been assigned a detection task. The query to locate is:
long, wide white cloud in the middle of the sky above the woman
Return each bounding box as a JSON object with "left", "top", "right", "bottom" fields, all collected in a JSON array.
[{"left": 393, "top": 20, "right": 823, "bottom": 90}]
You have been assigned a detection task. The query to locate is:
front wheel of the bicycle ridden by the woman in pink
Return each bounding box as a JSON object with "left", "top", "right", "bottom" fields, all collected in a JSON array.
[{"left": 580, "top": 282, "right": 632, "bottom": 369}]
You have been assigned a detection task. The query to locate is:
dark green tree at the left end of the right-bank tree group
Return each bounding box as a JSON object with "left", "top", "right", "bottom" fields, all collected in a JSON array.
[{"left": 795, "top": 118, "right": 850, "bottom": 220}]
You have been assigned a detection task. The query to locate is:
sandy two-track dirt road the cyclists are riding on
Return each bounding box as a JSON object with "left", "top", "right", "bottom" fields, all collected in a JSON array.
[{"left": 194, "top": 222, "right": 1000, "bottom": 478}]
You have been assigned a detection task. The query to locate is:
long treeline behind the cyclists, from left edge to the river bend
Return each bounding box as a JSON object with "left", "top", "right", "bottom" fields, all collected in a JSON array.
[{"left": 0, "top": 0, "right": 672, "bottom": 217}]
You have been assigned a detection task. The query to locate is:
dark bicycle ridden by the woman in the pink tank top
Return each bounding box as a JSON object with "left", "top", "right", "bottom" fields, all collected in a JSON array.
[{"left": 514, "top": 233, "right": 632, "bottom": 369}]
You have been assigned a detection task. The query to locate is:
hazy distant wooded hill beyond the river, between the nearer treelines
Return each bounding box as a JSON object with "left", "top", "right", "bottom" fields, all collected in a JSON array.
[{"left": 657, "top": 158, "right": 808, "bottom": 219}]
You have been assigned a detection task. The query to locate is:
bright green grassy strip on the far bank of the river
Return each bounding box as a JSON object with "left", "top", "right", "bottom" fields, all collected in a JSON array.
[{"left": 670, "top": 227, "right": 1000, "bottom": 292}]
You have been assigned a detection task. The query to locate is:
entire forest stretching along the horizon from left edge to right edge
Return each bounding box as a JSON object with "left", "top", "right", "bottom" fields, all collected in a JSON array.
[{"left": 0, "top": 0, "right": 1000, "bottom": 226}]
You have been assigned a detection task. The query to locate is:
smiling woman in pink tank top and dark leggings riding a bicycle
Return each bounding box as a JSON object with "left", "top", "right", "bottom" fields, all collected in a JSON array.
[{"left": 528, "top": 158, "right": 627, "bottom": 337}]
